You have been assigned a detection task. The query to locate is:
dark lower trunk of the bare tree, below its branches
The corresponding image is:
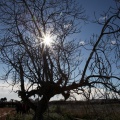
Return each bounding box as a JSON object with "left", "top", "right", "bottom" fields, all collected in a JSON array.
[{"left": 33, "top": 96, "right": 48, "bottom": 120}]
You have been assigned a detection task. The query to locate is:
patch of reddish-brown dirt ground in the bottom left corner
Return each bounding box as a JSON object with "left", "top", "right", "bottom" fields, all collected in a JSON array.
[{"left": 0, "top": 108, "right": 15, "bottom": 120}]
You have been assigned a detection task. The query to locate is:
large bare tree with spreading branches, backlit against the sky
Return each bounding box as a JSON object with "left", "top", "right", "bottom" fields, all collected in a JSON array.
[{"left": 0, "top": 0, "right": 120, "bottom": 120}]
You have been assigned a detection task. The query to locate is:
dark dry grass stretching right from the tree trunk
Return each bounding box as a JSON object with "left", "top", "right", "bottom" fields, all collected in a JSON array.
[{"left": 47, "top": 104, "right": 120, "bottom": 120}]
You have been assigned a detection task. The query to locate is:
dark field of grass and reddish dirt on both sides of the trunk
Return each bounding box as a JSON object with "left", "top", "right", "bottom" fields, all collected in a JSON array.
[{"left": 0, "top": 103, "right": 120, "bottom": 120}]
